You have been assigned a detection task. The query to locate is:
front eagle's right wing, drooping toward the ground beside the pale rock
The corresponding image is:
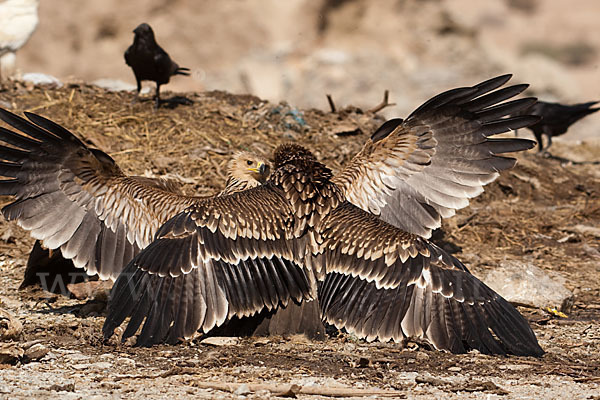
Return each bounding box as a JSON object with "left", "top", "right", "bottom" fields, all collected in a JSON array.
[{"left": 315, "top": 203, "right": 543, "bottom": 356}]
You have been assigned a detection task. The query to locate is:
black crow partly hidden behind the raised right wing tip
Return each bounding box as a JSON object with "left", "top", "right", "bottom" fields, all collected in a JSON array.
[{"left": 522, "top": 101, "right": 600, "bottom": 152}]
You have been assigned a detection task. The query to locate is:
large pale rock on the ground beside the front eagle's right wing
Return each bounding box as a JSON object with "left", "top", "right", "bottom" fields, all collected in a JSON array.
[{"left": 483, "top": 262, "right": 573, "bottom": 313}]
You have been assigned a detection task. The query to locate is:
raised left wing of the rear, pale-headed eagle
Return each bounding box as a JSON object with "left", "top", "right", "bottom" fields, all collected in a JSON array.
[{"left": 0, "top": 109, "right": 192, "bottom": 279}]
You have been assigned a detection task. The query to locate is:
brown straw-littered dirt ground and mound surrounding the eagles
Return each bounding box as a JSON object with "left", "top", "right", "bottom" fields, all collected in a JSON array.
[{"left": 0, "top": 83, "right": 600, "bottom": 399}]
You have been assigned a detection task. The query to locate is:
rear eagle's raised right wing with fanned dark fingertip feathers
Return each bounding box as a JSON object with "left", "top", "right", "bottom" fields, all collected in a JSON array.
[{"left": 334, "top": 75, "right": 539, "bottom": 237}]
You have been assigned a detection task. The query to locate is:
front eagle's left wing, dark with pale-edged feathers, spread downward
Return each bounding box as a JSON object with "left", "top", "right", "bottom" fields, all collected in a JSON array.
[{"left": 103, "top": 185, "right": 312, "bottom": 345}]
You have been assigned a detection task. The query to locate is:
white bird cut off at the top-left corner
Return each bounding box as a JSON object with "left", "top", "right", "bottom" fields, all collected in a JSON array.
[{"left": 0, "top": 0, "right": 39, "bottom": 80}]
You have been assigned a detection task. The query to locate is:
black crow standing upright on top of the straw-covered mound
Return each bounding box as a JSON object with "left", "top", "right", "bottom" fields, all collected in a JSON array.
[{"left": 125, "top": 23, "right": 190, "bottom": 108}]
